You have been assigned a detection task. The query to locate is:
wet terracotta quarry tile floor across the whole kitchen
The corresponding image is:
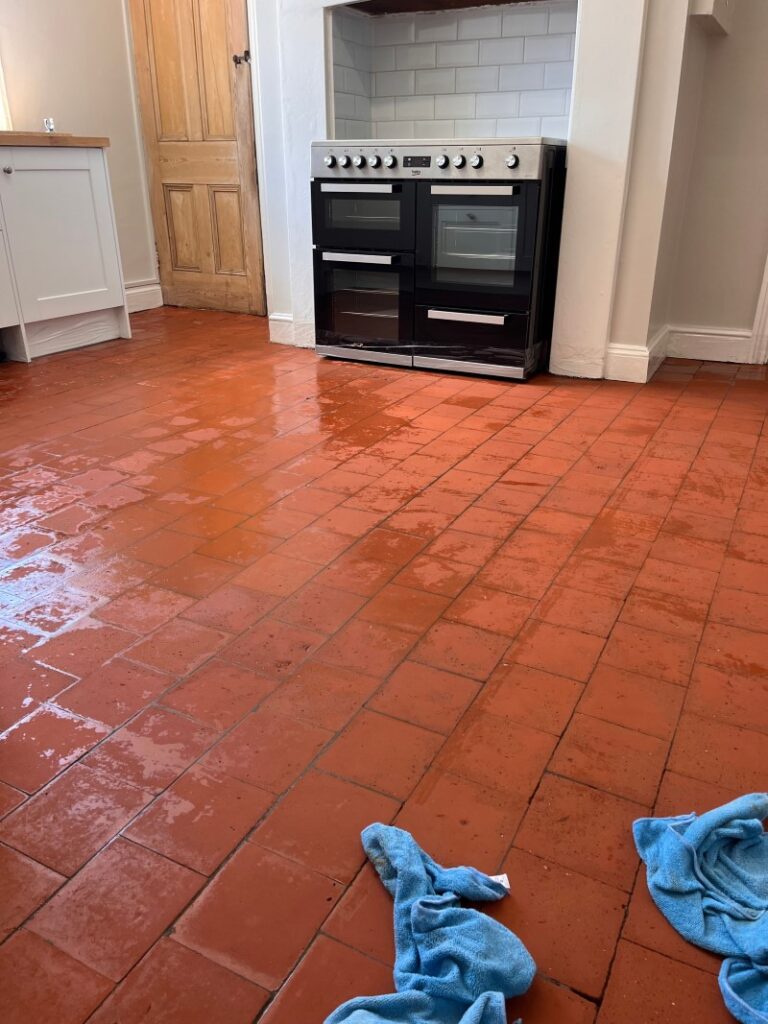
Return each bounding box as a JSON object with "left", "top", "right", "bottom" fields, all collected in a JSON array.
[{"left": 0, "top": 309, "right": 768, "bottom": 1024}]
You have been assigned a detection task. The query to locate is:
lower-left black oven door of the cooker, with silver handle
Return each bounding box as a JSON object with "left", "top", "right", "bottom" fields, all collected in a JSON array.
[{"left": 314, "top": 249, "right": 414, "bottom": 367}]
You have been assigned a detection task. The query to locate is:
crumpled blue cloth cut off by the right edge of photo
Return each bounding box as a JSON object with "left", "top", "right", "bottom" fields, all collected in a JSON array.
[{"left": 633, "top": 793, "right": 768, "bottom": 1024}]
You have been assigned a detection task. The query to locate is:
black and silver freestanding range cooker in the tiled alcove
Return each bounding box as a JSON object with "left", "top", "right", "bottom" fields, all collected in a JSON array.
[{"left": 311, "top": 138, "right": 565, "bottom": 379}]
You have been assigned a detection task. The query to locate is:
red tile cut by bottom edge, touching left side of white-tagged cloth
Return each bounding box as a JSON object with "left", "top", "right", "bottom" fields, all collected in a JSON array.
[{"left": 261, "top": 935, "right": 392, "bottom": 1024}]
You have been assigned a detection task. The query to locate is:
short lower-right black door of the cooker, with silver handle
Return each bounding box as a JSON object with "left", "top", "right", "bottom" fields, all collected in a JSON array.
[{"left": 414, "top": 306, "right": 535, "bottom": 380}]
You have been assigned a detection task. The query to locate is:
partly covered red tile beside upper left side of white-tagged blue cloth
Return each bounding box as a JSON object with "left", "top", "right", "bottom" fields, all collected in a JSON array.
[{"left": 323, "top": 863, "right": 394, "bottom": 965}]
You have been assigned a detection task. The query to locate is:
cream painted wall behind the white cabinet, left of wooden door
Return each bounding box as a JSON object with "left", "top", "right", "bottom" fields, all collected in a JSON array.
[{"left": 0, "top": 0, "right": 160, "bottom": 308}]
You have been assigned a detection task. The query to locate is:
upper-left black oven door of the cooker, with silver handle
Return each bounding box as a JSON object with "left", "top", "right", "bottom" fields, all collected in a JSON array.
[{"left": 312, "top": 180, "right": 416, "bottom": 252}]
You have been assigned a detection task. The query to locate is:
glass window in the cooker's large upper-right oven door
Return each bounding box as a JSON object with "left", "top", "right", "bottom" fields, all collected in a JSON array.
[{"left": 432, "top": 203, "right": 519, "bottom": 288}]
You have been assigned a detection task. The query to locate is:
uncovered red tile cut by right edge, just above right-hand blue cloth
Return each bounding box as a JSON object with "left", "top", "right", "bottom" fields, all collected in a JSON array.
[{"left": 669, "top": 713, "right": 768, "bottom": 793}]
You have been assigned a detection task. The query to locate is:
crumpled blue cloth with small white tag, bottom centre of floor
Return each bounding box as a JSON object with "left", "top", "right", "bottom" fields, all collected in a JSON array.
[{"left": 326, "top": 824, "right": 536, "bottom": 1024}]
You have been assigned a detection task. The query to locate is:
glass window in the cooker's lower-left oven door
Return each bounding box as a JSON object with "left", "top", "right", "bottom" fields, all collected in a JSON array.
[{"left": 330, "top": 268, "right": 399, "bottom": 341}]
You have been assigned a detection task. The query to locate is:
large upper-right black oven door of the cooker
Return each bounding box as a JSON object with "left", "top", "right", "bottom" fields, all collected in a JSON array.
[{"left": 416, "top": 181, "right": 540, "bottom": 313}]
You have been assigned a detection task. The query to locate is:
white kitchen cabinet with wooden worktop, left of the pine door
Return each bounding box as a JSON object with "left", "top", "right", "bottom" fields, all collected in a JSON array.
[{"left": 0, "top": 133, "right": 130, "bottom": 359}]
